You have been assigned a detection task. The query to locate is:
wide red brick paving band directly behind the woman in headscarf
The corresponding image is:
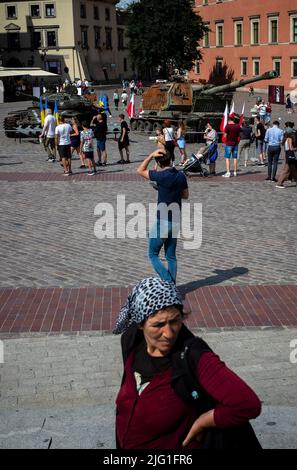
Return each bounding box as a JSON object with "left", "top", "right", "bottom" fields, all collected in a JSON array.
[{"left": 0, "top": 285, "right": 297, "bottom": 334}]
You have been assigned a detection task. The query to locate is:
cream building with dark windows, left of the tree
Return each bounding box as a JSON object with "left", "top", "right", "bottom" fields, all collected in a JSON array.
[{"left": 0, "top": 0, "right": 133, "bottom": 80}]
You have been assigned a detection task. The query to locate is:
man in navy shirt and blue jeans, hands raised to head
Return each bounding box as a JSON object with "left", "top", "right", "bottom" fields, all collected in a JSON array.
[{"left": 137, "top": 149, "right": 189, "bottom": 283}]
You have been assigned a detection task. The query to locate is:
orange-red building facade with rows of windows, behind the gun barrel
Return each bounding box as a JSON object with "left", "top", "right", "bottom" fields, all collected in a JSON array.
[{"left": 190, "top": 0, "right": 297, "bottom": 91}]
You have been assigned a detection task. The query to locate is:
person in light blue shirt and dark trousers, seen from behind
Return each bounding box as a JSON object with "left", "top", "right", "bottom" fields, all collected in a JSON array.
[{"left": 264, "top": 121, "right": 284, "bottom": 181}]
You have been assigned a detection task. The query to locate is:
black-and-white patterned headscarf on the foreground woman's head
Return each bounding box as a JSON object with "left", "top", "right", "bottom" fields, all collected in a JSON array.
[{"left": 113, "top": 277, "right": 182, "bottom": 335}]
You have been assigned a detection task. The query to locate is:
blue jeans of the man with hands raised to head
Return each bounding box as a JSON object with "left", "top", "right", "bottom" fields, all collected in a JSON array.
[{"left": 148, "top": 220, "right": 179, "bottom": 283}]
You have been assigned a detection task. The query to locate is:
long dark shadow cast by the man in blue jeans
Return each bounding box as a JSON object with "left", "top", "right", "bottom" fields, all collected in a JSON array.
[{"left": 178, "top": 266, "right": 249, "bottom": 298}]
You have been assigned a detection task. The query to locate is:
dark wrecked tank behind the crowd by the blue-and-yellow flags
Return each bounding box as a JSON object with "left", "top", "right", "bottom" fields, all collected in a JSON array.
[{"left": 4, "top": 85, "right": 98, "bottom": 137}]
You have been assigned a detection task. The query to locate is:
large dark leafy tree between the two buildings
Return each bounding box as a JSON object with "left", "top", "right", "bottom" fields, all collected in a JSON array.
[{"left": 127, "top": 0, "right": 208, "bottom": 77}]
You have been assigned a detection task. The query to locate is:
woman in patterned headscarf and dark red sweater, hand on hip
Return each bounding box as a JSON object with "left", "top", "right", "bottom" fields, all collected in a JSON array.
[{"left": 114, "top": 278, "right": 261, "bottom": 449}]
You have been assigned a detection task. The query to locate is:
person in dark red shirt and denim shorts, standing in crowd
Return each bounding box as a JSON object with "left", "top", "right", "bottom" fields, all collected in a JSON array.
[{"left": 222, "top": 115, "right": 241, "bottom": 178}]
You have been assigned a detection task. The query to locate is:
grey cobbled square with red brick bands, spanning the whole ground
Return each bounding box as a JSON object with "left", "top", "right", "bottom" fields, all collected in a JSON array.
[{"left": 0, "top": 93, "right": 297, "bottom": 448}]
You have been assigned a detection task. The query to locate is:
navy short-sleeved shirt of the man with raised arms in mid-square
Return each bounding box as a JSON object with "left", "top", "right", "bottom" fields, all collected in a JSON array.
[{"left": 149, "top": 168, "right": 188, "bottom": 221}]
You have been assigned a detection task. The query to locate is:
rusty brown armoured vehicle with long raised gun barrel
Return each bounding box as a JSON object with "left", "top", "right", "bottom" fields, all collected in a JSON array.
[{"left": 130, "top": 70, "right": 278, "bottom": 142}]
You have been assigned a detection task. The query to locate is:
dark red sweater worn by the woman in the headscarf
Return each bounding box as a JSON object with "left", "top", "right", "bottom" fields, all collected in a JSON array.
[{"left": 116, "top": 352, "right": 261, "bottom": 449}]
